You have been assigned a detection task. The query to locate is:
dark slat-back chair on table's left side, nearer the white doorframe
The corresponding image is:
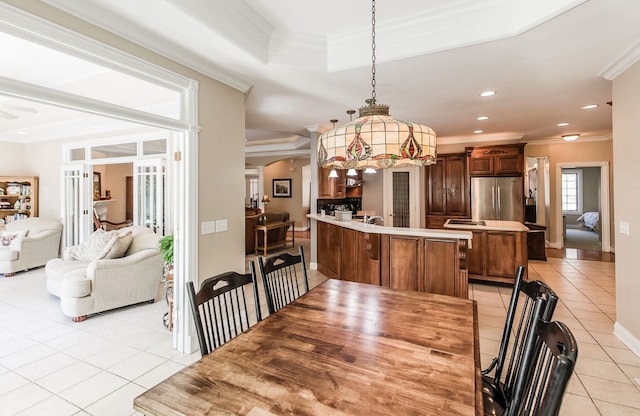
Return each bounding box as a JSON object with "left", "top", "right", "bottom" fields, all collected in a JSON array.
[{"left": 186, "top": 261, "right": 262, "bottom": 357}]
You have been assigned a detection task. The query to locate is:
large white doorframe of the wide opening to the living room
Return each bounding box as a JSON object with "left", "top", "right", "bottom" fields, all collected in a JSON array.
[{"left": 0, "top": 2, "right": 200, "bottom": 353}]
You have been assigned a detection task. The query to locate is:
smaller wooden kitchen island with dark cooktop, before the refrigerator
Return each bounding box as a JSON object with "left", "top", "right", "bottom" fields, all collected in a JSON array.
[{"left": 444, "top": 220, "right": 529, "bottom": 284}]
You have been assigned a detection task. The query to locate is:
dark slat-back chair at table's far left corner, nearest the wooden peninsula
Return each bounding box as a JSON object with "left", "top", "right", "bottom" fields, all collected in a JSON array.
[{"left": 258, "top": 246, "right": 309, "bottom": 314}]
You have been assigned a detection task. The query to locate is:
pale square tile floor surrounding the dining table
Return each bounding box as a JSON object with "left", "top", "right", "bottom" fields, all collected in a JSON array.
[{"left": 0, "top": 245, "right": 640, "bottom": 416}]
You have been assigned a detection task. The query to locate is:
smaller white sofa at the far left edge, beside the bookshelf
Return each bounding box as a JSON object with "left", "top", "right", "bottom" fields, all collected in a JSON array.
[{"left": 0, "top": 217, "right": 62, "bottom": 277}]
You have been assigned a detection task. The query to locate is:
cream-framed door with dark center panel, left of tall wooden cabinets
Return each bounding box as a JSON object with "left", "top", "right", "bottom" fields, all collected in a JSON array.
[{"left": 383, "top": 167, "right": 421, "bottom": 228}]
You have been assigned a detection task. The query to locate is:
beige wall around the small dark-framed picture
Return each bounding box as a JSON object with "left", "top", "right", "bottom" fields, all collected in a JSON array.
[{"left": 262, "top": 159, "right": 309, "bottom": 229}]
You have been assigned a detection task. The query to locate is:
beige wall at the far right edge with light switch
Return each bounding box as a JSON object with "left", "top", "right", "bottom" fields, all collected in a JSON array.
[{"left": 613, "top": 58, "right": 640, "bottom": 344}]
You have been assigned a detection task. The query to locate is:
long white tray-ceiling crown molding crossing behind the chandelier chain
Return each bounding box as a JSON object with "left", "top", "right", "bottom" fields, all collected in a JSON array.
[{"left": 327, "top": 0, "right": 586, "bottom": 72}]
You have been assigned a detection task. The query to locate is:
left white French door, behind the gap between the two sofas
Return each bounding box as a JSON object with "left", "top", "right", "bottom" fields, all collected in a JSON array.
[{"left": 61, "top": 163, "right": 93, "bottom": 247}]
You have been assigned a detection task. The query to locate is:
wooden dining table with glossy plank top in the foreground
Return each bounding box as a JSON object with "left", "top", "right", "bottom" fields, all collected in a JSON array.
[{"left": 134, "top": 279, "right": 483, "bottom": 416}]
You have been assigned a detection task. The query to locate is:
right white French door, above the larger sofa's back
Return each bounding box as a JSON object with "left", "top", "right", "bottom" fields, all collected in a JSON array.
[{"left": 133, "top": 158, "right": 166, "bottom": 235}]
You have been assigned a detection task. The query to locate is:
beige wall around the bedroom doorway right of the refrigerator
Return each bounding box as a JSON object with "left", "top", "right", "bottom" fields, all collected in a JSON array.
[{"left": 524, "top": 140, "right": 614, "bottom": 246}]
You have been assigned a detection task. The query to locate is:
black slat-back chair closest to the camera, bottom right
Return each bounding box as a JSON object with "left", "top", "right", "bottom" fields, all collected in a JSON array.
[{"left": 505, "top": 320, "right": 578, "bottom": 416}]
